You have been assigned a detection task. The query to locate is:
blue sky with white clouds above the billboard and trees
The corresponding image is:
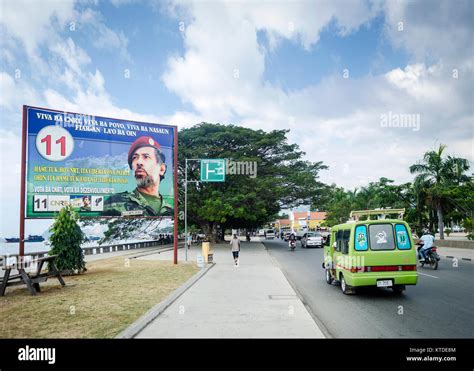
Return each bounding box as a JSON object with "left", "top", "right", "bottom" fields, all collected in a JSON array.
[{"left": 0, "top": 0, "right": 474, "bottom": 236}]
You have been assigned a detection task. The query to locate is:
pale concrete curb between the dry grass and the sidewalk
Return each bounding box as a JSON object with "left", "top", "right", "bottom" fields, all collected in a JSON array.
[{"left": 115, "top": 263, "right": 216, "bottom": 339}]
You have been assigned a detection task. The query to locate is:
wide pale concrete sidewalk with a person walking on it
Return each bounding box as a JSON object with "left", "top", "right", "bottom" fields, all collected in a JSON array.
[{"left": 136, "top": 242, "right": 324, "bottom": 338}]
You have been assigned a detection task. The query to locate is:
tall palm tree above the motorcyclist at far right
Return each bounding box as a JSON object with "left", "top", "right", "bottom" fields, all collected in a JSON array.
[{"left": 410, "top": 144, "right": 469, "bottom": 239}]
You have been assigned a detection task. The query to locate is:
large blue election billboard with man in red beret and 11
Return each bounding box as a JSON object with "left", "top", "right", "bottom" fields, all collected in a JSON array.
[{"left": 24, "top": 106, "right": 176, "bottom": 218}]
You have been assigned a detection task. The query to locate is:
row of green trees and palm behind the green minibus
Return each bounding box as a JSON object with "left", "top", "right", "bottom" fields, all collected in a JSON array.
[{"left": 320, "top": 145, "right": 474, "bottom": 239}]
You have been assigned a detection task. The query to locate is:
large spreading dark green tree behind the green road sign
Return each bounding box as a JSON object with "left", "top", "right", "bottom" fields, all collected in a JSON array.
[{"left": 178, "top": 123, "right": 327, "bottom": 241}]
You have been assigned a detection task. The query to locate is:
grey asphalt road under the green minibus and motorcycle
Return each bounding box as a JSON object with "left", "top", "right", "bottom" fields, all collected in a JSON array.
[{"left": 264, "top": 239, "right": 474, "bottom": 338}]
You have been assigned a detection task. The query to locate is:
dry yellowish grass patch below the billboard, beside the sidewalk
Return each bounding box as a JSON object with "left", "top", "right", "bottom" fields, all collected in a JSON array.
[{"left": 0, "top": 256, "right": 199, "bottom": 338}]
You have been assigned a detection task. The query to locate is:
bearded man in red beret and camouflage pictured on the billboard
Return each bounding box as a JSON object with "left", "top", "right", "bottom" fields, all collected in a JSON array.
[{"left": 106, "top": 136, "right": 173, "bottom": 216}]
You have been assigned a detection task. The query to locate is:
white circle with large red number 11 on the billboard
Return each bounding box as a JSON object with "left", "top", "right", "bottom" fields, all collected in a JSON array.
[{"left": 36, "top": 125, "right": 74, "bottom": 161}]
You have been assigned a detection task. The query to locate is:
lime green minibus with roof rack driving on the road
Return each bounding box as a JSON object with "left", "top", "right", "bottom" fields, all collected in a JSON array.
[{"left": 323, "top": 219, "right": 418, "bottom": 294}]
